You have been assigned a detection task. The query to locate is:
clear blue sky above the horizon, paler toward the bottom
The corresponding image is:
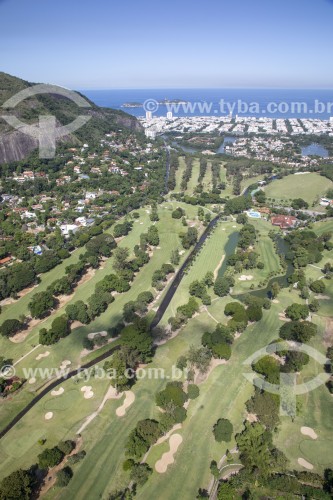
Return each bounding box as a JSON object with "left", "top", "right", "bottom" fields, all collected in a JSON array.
[{"left": 0, "top": 0, "right": 333, "bottom": 89}]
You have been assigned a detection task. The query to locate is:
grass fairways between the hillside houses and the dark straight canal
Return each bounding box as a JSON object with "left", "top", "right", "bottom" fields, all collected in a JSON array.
[{"left": 0, "top": 203, "right": 202, "bottom": 427}]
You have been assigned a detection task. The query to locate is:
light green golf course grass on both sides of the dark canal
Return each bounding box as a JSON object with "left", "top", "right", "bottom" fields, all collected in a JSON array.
[{"left": 0, "top": 200, "right": 333, "bottom": 500}]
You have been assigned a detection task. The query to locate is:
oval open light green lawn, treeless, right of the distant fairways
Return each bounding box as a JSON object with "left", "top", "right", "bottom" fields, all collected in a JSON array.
[{"left": 265, "top": 173, "right": 333, "bottom": 207}]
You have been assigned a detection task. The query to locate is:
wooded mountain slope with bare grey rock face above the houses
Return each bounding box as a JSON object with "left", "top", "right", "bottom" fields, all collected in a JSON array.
[{"left": 0, "top": 72, "right": 143, "bottom": 164}]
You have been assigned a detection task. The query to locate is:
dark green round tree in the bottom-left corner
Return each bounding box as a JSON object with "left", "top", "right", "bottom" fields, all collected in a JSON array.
[{"left": 0, "top": 469, "right": 34, "bottom": 500}]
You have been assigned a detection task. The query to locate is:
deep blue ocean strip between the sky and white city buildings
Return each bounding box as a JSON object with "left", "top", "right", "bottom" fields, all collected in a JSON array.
[{"left": 80, "top": 89, "right": 333, "bottom": 120}]
